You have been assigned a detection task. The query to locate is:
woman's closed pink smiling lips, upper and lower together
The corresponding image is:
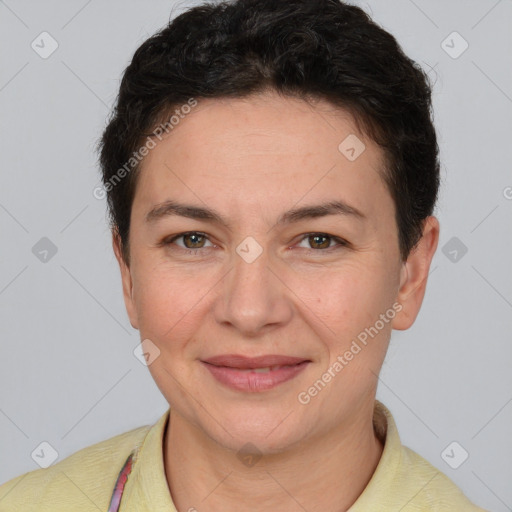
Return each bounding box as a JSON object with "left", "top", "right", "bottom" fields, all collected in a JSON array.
[{"left": 201, "top": 354, "right": 311, "bottom": 392}]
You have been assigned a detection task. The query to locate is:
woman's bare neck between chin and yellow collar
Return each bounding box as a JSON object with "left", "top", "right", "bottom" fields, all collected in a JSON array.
[{"left": 164, "top": 402, "right": 383, "bottom": 512}]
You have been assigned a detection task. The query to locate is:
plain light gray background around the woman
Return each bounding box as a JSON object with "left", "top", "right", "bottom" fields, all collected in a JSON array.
[{"left": 0, "top": 0, "right": 512, "bottom": 511}]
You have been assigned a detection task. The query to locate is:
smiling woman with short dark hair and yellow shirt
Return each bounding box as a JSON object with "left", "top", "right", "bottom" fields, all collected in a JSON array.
[{"left": 0, "top": 0, "right": 483, "bottom": 512}]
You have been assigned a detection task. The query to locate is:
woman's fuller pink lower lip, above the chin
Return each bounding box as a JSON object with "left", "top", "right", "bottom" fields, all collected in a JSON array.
[{"left": 202, "top": 361, "right": 309, "bottom": 393}]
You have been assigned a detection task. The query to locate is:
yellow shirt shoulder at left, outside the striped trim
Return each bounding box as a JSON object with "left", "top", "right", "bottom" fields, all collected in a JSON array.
[{"left": 0, "top": 425, "right": 151, "bottom": 512}]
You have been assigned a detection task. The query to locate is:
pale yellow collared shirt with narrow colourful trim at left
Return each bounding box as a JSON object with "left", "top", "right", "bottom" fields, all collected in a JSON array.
[{"left": 0, "top": 400, "right": 486, "bottom": 512}]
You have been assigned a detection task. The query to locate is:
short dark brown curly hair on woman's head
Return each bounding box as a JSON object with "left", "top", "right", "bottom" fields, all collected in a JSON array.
[{"left": 97, "top": 0, "right": 439, "bottom": 263}]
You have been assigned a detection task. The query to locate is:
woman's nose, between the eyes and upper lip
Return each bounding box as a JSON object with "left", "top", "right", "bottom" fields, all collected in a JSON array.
[{"left": 215, "top": 243, "right": 293, "bottom": 337}]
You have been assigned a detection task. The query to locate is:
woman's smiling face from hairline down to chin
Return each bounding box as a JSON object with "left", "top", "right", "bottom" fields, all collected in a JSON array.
[{"left": 116, "top": 93, "right": 428, "bottom": 453}]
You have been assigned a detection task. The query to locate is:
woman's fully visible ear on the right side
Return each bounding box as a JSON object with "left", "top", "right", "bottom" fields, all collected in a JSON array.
[{"left": 392, "top": 216, "right": 439, "bottom": 331}]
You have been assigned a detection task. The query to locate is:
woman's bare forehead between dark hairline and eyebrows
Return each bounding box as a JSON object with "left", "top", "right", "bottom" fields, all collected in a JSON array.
[{"left": 134, "top": 93, "right": 392, "bottom": 228}]
